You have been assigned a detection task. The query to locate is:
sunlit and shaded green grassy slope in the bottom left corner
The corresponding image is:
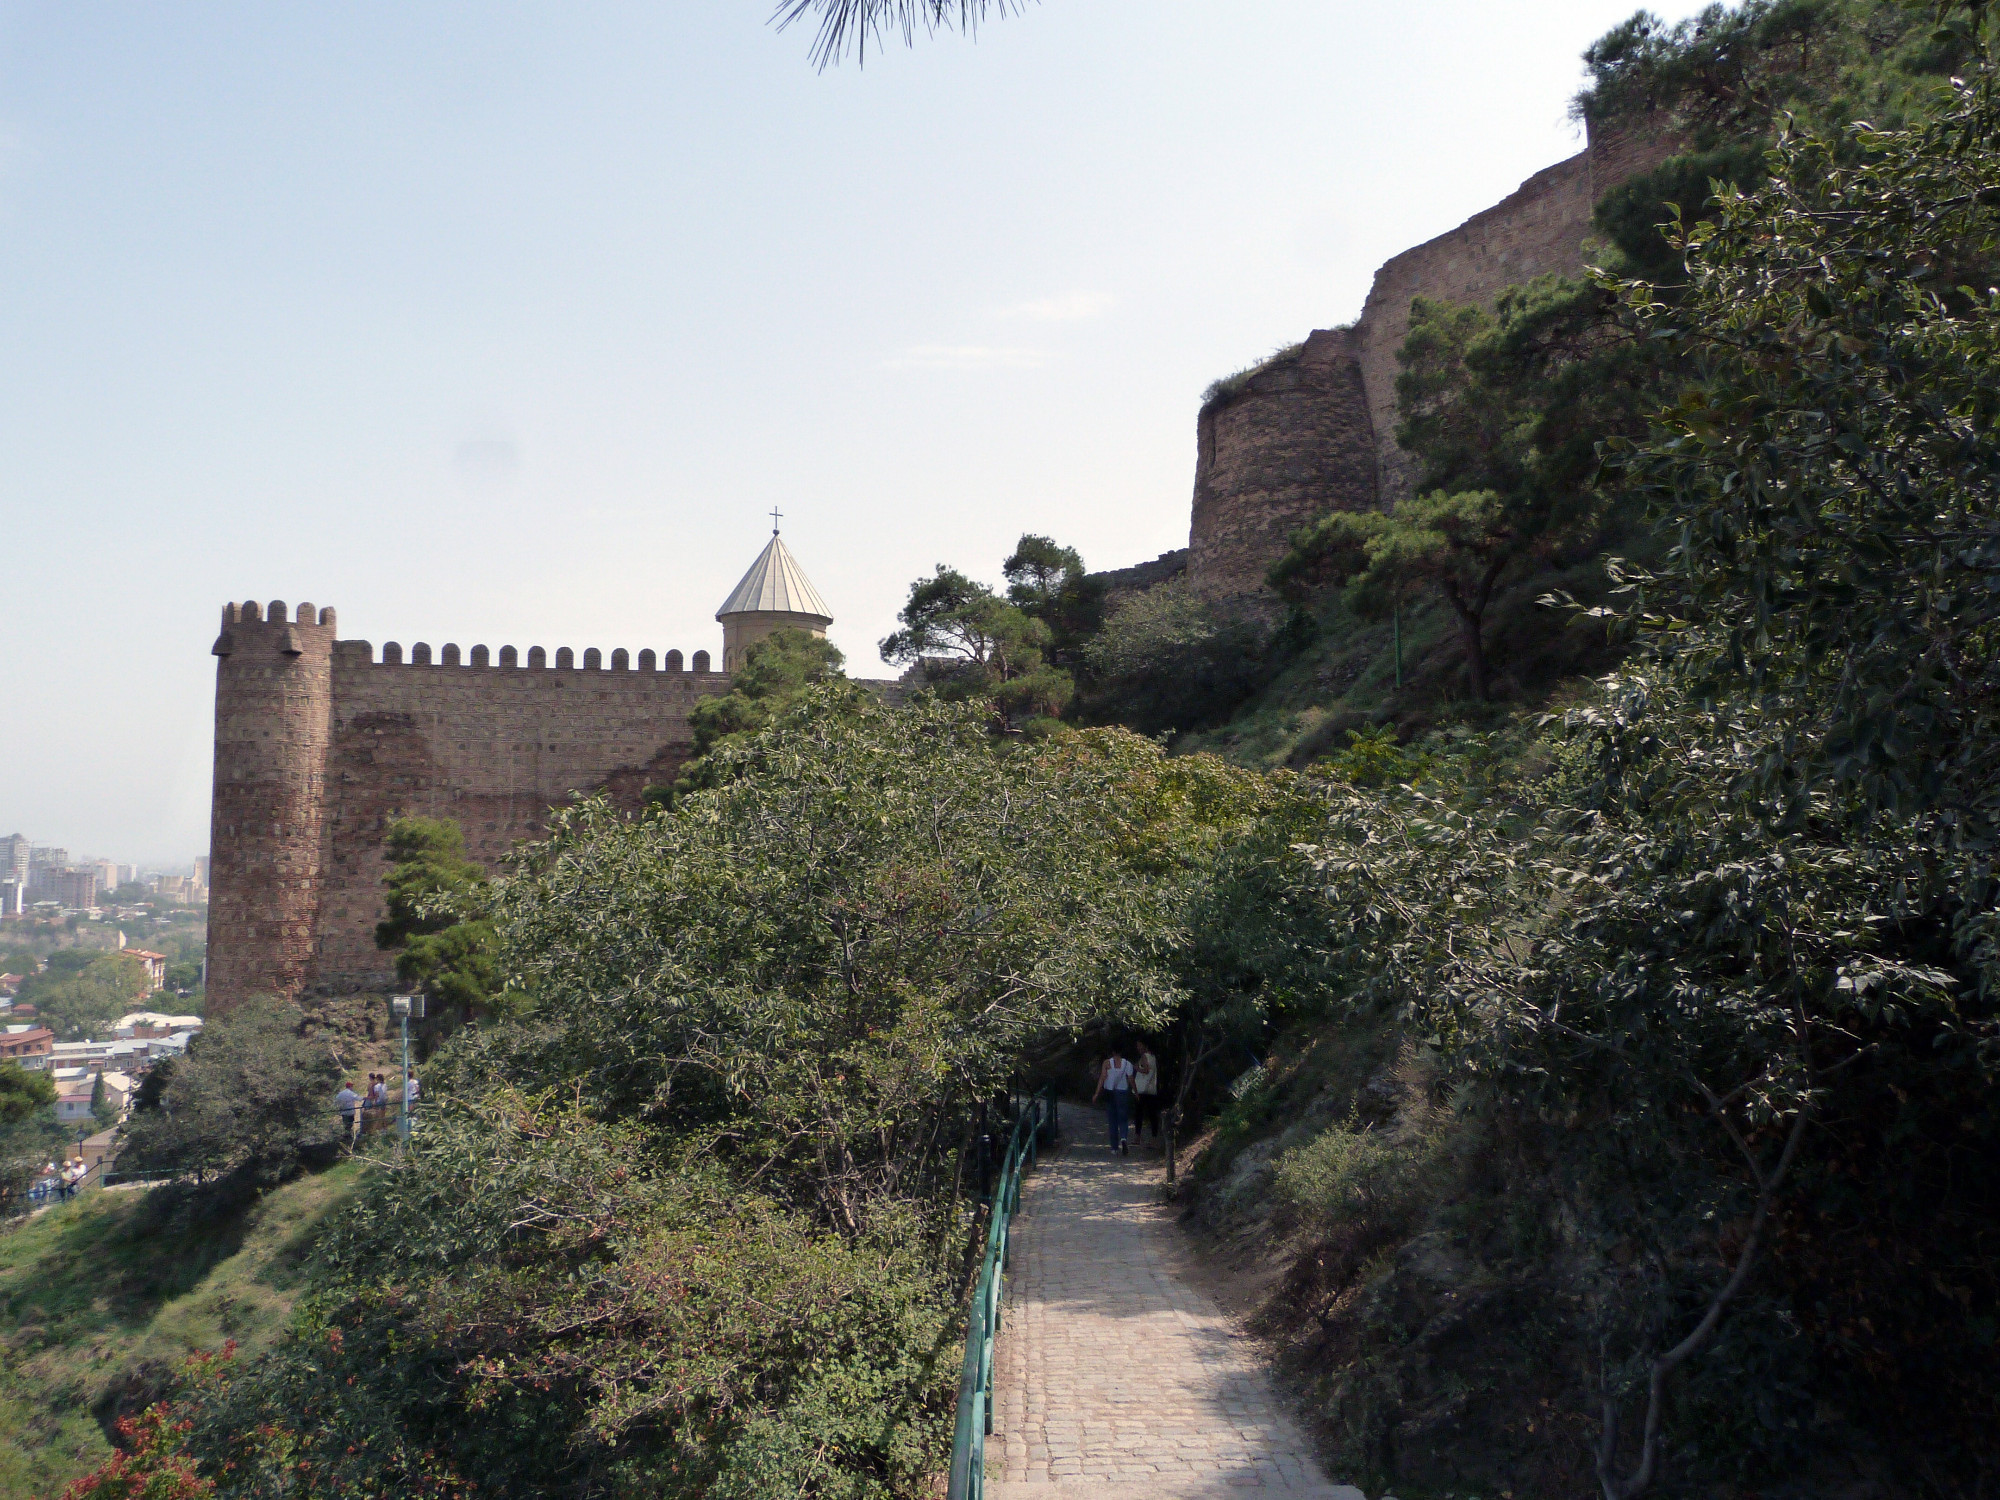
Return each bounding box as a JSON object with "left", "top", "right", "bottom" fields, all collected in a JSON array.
[{"left": 0, "top": 1164, "right": 362, "bottom": 1500}]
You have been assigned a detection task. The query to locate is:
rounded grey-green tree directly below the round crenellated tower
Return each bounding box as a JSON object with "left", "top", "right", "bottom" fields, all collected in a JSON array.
[{"left": 118, "top": 996, "right": 340, "bottom": 1192}]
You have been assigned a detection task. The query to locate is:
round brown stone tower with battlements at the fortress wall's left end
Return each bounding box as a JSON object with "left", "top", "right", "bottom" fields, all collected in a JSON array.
[{"left": 208, "top": 600, "right": 334, "bottom": 1016}]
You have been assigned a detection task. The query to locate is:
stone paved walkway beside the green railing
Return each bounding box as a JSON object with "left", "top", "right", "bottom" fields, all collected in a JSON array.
[{"left": 986, "top": 1106, "right": 1364, "bottom": 1500}]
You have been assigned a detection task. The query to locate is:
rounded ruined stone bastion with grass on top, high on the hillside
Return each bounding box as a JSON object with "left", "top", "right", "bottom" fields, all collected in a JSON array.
[{"left": 1188, "top": 328, "right": 1376, "bottom": 596}]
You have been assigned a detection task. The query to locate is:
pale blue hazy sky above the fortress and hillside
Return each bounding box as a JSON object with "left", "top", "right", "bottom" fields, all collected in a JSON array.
[{"left": 0, "top": 0, "right": 1720, "bottom": 864}]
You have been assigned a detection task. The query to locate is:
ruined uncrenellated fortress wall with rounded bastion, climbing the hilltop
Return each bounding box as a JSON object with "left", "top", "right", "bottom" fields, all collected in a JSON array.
[{"left": 1188, "top": 128, "right": 1678, "bottom": 598}]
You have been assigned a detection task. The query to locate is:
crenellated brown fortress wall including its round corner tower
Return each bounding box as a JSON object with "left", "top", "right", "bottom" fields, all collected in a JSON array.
[{"left": 208, "top": 602, "right": 730, "bottom": 1012}]
